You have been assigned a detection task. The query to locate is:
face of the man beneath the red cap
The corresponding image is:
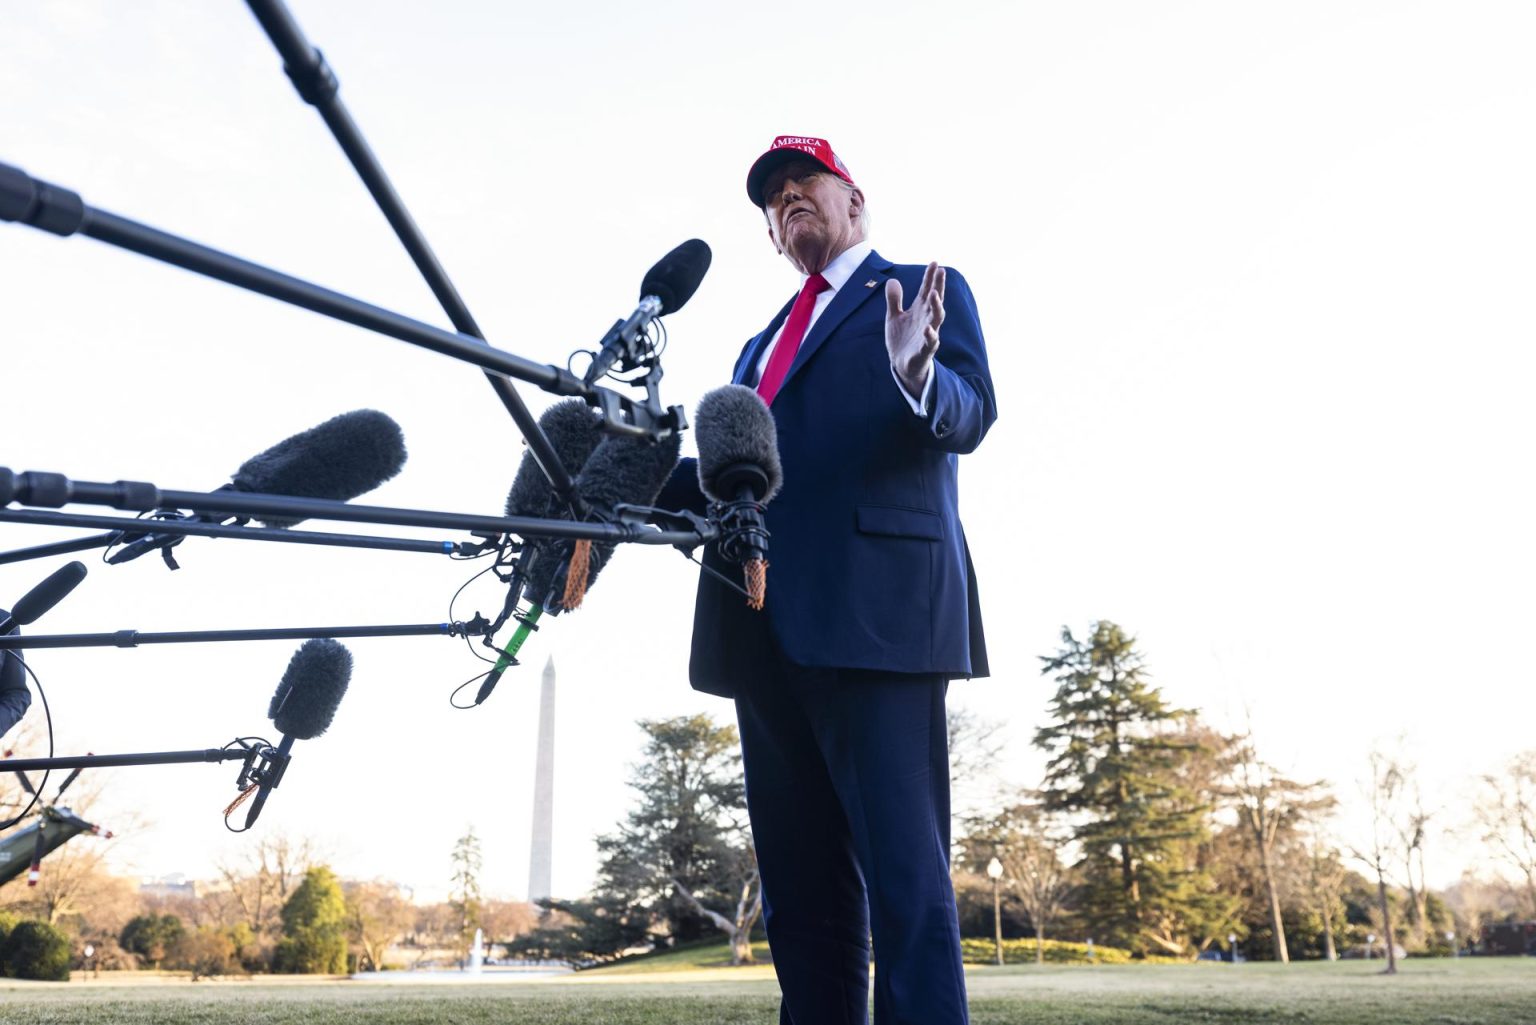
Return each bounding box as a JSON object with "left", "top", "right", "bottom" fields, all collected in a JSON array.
[{"left": 763, "top": 157, "right": 863, "bottom": 274}]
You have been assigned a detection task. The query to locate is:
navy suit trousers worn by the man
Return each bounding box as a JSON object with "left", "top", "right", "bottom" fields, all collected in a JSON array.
[{"left": 736, "top": 645, "right": 968, "bottom": 1025}]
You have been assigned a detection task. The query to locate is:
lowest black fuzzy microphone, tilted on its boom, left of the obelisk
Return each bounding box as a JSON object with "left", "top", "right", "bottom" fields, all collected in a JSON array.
[{"left": 239, "top": 638, "right": 352, "bottom": 830}]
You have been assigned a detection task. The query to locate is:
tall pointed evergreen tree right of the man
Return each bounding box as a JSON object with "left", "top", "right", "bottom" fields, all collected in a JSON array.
[{"left": 1035, "top": 621, "right": 1223, "bottom": 954}]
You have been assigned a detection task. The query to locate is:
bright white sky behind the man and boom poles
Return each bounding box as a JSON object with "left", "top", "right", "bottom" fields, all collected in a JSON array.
[{"left": 0, "top": 0, "right": 1536, "bottom": 896}]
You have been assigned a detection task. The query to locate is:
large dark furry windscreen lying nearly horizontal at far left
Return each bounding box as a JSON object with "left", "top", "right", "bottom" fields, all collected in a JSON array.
[{"left": 232, "top": 409, "right": 406, "bottom": 527}]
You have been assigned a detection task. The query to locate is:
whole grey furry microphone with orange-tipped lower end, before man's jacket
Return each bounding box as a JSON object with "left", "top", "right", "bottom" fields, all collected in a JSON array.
[{"left": 694, "top": 384, "right": 783, "bottom": 609}]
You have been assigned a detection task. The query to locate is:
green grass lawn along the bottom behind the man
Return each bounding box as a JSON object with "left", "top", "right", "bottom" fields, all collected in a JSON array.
[{"left": 0, "top": 957, "right": 1536, "bottom": 1025}]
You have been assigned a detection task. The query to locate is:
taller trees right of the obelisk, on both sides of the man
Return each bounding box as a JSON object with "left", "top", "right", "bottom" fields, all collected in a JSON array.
[{"left": 515, "top": 621, "right": 1536, "bottom": 970}]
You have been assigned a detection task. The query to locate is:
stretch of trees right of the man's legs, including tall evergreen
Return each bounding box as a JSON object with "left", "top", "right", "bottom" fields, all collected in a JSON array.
[{"left": 954, "top": 621, "right": 1536, "bottom": 971}]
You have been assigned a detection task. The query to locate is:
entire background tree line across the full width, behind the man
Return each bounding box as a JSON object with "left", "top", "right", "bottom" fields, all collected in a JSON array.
[{"left": 0, "top": 621, "right": 1536, "bottom": 973}]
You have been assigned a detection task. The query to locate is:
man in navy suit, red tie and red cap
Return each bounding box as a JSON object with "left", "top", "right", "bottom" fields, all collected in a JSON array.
[{"left": 662, "top": 137, "right": 997, "bottom": 1025}]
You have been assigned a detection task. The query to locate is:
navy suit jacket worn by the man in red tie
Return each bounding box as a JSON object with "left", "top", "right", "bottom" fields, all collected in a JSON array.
[{"left": 659, "top": 252, "right": 997, "bottom": 696}]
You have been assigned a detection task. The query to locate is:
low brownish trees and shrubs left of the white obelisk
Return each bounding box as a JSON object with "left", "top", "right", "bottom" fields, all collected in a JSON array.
[{"left": 0, "top": 830, "right": 538, "bottom": 977}]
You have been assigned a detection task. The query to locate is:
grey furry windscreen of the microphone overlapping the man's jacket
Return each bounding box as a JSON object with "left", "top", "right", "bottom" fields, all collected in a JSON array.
[{"left": 693, "top": 384, "right": 783, "bottom": 503}]
